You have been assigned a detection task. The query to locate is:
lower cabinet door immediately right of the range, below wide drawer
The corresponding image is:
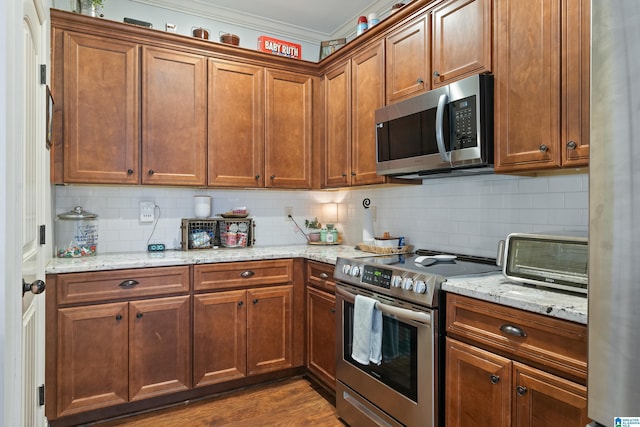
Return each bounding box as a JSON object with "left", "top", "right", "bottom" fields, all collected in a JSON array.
[{"left": 444, "top": 338, "right": 510, "bottom": 427}]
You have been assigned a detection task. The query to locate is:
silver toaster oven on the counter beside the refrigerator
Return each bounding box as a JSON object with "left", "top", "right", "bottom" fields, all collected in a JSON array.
[{"left": 497, "top": 233, "right": 589, "bottom": 294}]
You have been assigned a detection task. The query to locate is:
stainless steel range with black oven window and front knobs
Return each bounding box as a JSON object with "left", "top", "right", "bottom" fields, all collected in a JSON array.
[{"left": 334, "top": 251, "right": 500, "bottom": 427}]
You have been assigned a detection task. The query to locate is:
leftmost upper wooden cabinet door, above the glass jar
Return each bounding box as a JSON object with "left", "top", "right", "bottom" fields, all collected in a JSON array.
[{"left": 62, "top": 32, "right": 140, "bottom": 184}]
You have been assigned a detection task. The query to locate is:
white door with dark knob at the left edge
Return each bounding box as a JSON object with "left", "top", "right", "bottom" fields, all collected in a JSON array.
[{"left": 16, "top": 0, "right": 48, "bottom": 427}]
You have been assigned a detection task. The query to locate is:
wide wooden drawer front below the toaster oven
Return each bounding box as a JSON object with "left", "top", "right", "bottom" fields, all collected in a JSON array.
[{"left": 446, "top": 294, "right": 587, "bottom": 383}]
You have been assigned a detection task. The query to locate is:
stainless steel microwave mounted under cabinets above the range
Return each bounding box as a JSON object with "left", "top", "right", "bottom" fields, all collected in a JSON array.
[{"left": 375, "top": 74, "right": 493, "bottom": 178}]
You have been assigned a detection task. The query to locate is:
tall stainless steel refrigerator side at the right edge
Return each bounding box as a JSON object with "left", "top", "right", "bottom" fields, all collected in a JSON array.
[{"left": 587, "top": 0, "right": 640, "bottom": 426}]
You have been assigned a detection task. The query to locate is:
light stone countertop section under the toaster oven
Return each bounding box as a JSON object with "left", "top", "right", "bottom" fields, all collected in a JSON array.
[{"left": 442, "top": 273, "right": 587, "bottom": 325}]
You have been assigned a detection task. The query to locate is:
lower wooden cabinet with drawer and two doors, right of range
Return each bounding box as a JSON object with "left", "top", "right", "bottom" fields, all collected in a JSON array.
[{"left": 444, "top": 294, "right": 589, "bottom": 427}]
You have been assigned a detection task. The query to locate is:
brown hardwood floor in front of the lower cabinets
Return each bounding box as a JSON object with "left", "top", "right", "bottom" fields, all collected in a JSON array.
[{"left": 93, "top": 377, "right": 345, "bottom": 427}]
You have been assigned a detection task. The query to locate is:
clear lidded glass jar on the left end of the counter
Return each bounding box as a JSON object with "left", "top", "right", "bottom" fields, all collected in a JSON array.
[{"left": 56, "top": 206, "right": 98, "bottom": 258}]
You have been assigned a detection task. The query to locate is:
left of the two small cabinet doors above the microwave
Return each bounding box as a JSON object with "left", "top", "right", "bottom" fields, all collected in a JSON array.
[{"left": 385, "top": 16, "right": 431, "bottom": 104}]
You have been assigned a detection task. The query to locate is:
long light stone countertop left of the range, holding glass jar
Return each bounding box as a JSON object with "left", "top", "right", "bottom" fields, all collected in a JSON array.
[{"left": 45, "top": 245, "right": 370, "bottom": 274}]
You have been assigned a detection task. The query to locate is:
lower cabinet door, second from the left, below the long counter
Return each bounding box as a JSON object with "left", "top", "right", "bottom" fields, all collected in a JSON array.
[{"left": 129, "top": 296, "right": 191, "bottom": 401}]
